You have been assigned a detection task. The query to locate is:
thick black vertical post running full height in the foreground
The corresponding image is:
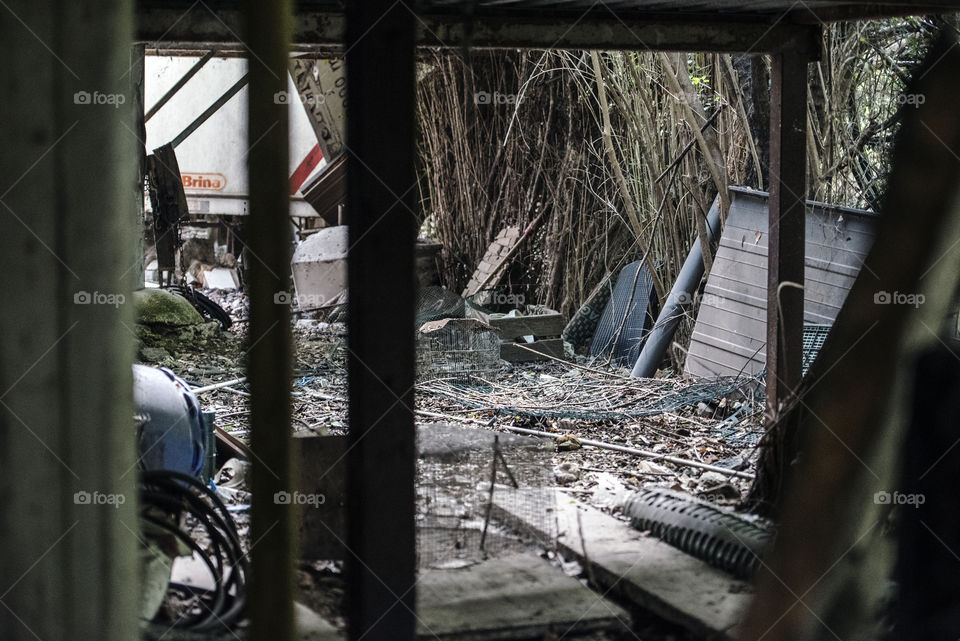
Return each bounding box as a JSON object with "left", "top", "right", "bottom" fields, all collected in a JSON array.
[{"left": 345, "top": 0, "right": 416, "bottom": 641}]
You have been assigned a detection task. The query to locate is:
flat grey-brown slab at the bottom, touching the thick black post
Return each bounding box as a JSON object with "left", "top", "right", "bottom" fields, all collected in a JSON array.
[{"left": 417, "top": 553, "right": 629, "bottom": 641}]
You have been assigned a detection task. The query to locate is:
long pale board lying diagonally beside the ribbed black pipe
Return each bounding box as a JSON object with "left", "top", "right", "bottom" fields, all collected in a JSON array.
[{"left": 494, "top": 490, "right": 753, "bottom": 640}]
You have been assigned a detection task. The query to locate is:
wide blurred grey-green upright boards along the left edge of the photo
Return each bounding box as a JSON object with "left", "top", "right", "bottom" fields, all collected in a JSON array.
[{"left": 0, "top": 0, "right": 140, "bottom": 641}]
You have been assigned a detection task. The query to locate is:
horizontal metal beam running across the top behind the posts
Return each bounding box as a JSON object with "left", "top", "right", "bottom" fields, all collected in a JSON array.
[{"left": 137, "top": 5, "right": 820, "bottom": 58}]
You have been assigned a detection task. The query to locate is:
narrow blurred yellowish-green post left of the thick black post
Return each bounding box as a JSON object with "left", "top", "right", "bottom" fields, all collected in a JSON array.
[{"left": 244, "top": 0, "right": 296, "bottom": 641}]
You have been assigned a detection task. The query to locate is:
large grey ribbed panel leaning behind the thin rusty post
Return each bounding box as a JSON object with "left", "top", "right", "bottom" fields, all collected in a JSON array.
[{"left": 684, "top": 188, "right": 878, "bottom": 376}]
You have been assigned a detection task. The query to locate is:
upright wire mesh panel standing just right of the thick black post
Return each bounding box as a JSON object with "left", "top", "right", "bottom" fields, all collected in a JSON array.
[{"left": 417, "top": 424, "right": 557, "bottom": 569}]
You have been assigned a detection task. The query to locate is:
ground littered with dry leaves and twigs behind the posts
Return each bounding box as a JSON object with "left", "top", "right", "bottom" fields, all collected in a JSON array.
[{"left": 141, "top": 292, "right": 762, "bottom": 641}]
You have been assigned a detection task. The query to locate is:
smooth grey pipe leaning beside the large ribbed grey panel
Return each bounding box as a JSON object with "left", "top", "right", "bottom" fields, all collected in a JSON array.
[{"left": 630, "top": 199, "right": 720, "bottom": 378}]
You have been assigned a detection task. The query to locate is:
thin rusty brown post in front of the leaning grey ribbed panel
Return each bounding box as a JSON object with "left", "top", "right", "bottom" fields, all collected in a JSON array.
[{"left": 766, "top": 53, "right": 808, "bottom": 423}]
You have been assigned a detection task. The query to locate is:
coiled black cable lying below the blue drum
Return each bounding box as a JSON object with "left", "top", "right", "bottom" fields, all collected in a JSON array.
[{"left": 139, "top": 470, "right": 247, "bottom": 631}]
